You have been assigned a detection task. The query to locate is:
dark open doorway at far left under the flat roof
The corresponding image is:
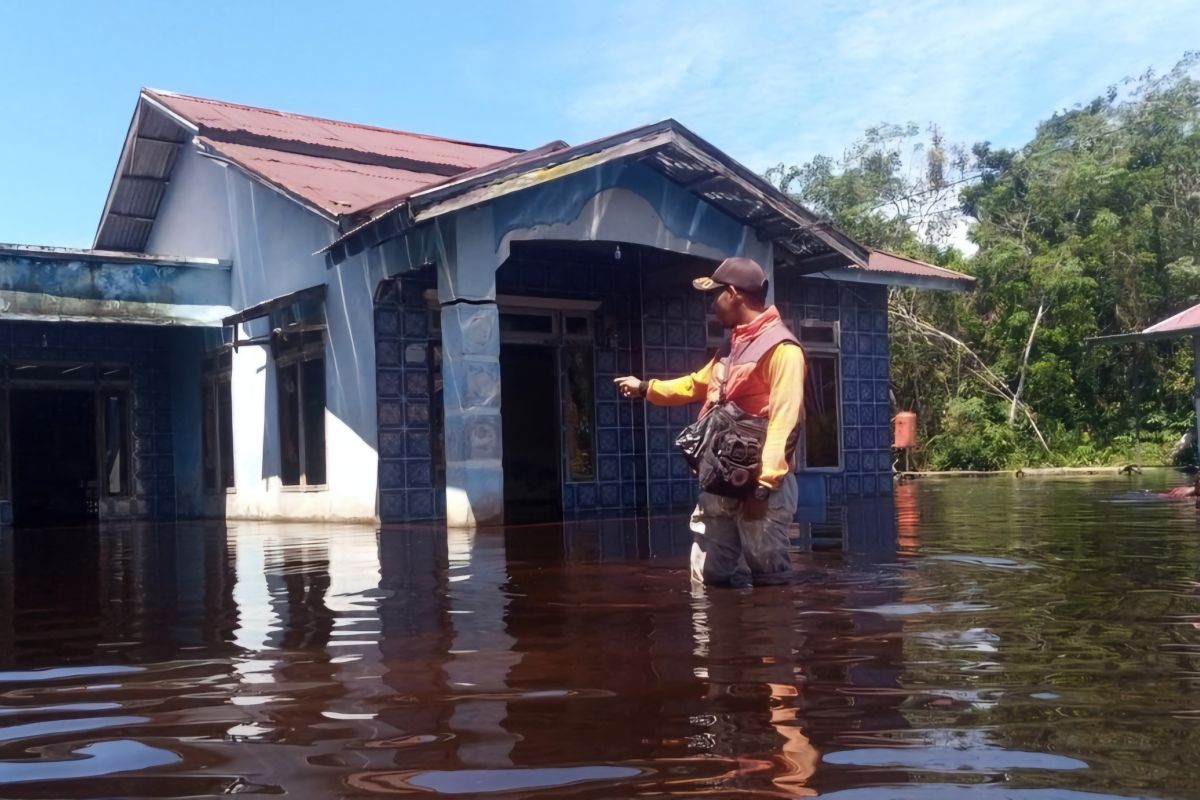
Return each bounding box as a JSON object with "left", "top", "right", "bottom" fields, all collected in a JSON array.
[{"left": 10, "top": 389, "right": 98, "bottom": 527}]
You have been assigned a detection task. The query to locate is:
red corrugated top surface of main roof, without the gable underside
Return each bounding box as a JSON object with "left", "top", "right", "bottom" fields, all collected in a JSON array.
[{"left": 144, "top": 89, "right": 521, "bottom": 217}]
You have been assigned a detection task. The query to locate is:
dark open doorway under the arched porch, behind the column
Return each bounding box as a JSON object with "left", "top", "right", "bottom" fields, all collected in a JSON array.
[{"left": 500, "top": 344, "right": 563, "bottom": 524}]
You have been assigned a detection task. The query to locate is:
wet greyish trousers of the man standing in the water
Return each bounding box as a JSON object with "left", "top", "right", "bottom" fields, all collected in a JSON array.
[{"left": 691, "top": 475, "right": 797, "bottom": 587}]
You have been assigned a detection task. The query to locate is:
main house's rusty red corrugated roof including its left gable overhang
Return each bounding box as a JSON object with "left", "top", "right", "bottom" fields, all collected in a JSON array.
[{"left": 94, "top": 89, "right": 523, "bottom": 251}]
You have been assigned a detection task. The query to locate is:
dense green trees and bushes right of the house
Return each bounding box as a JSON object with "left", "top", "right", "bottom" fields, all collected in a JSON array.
[{"left": 768, "top": 54, "right": 1200, "bottom": 469}]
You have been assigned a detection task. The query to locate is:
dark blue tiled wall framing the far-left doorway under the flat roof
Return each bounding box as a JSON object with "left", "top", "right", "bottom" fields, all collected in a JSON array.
[{"left": 0, "top": 321, "right": 175, "bottom": 519}]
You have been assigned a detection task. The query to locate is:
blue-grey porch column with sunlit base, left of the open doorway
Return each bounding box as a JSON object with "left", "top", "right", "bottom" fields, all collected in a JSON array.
[{"left": 438, "top": 209, "right": 504, "bottom": 528}]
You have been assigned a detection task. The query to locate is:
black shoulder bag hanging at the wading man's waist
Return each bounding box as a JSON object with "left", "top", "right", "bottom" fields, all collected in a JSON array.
[{"left": 676, "top": 401, "right": 767, "bottom": 499}]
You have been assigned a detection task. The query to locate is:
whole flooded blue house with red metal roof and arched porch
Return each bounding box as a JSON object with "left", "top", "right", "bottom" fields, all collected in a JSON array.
[{"left": 0, "top": 90, "right": 970, "bottom": 527}]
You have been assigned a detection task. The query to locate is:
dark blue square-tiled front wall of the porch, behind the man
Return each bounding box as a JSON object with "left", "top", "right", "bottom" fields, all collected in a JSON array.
[{"left": 376, "top": 259, "right": 892, "bottom": 522}]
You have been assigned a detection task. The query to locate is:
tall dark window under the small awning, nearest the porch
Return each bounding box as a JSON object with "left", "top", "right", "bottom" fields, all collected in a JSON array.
[{"left": 274, "top": 330, "right": 325, "bottom": 486}]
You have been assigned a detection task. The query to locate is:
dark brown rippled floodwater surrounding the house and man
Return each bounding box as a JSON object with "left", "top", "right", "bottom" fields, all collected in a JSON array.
[{"left": 0, "top": 473, "right": 1200, "bottom": 800}]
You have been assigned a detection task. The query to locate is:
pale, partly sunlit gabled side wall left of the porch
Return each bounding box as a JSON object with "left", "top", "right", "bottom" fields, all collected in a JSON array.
[{"left": 148, "top": 148, "right": 382, "bottom": 521}]
